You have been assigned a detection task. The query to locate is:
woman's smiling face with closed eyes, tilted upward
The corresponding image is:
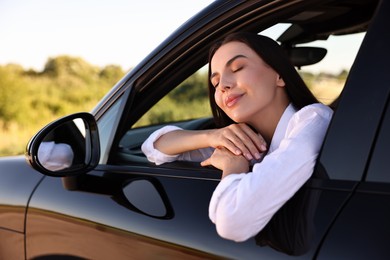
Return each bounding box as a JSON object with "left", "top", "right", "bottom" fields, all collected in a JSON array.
[{"left": 210, "top": 42, "right": 286, "bottom": 124}]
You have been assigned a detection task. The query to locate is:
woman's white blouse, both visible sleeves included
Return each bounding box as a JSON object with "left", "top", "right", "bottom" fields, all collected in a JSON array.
[{"left": 142, "top": 104, "right": 333, "bottom": 242}]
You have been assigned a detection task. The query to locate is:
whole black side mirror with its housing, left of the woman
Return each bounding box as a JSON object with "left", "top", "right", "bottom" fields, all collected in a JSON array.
[{"left": 26, "top": 113, "right": 100, "bottom": 177}]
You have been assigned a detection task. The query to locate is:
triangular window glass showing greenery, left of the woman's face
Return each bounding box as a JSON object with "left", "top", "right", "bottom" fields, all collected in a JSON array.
[{"left": 134, "top": 67, "right": 211, "bottom": 127}]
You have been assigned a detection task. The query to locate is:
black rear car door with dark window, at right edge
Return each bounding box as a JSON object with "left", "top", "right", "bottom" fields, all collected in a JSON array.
[{"left": 319, "top": 98, "right": 390, "bottom": 259}]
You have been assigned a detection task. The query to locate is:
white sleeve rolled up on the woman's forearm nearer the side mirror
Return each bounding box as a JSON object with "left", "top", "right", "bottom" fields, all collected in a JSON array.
[{"left": 141, "top": 125, "right": 213, "bottom": 165}]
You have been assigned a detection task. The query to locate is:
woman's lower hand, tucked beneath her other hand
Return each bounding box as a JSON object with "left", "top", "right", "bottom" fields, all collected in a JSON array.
[{"left": 201, "top": 147, "right": 249, "bottom": 178}]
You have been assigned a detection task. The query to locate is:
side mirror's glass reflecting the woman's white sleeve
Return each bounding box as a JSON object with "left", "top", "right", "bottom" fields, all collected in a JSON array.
[{"left": 37, "top": 118, "right": 91, "bottom": 172}]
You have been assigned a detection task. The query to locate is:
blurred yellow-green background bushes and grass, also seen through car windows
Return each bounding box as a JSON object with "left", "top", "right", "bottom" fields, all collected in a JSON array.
[{"left": 0, "top": 56, "right": 347, "bottom": 156}]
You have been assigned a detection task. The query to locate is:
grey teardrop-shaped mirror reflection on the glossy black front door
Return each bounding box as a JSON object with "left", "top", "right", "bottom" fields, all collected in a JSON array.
[{"left": 123, "top": 180, "right": 167, "bottom": 217}]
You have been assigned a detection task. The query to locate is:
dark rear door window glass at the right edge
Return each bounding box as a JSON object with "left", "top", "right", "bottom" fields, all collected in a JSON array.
[{"left": 366, "top": 100, "right": 390, "bottom": 183}]
